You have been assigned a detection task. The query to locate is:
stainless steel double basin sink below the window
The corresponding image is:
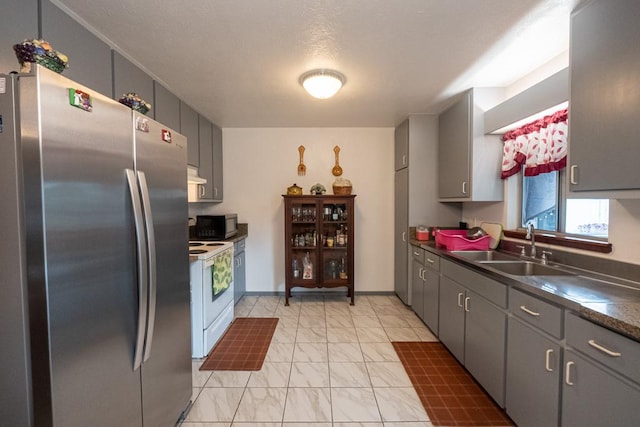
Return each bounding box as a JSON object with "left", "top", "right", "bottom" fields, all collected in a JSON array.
[{"left": 451, "top": 251, "right": 573, "bottom": 276}]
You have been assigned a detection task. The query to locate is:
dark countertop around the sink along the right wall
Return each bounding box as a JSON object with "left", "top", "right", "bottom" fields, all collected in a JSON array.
[{"left": 409, "top": 239, "right": 640, "bottom": 342}]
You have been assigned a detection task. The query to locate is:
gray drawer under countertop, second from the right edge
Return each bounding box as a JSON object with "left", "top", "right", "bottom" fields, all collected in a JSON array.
[{"left": 509, "top": 288, "right": 562, "bottom": 338}]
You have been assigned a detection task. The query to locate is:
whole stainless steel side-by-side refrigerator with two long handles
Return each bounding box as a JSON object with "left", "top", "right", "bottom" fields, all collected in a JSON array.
[{"left": 0, "top": 67, "right": 192, "bottom": 427}]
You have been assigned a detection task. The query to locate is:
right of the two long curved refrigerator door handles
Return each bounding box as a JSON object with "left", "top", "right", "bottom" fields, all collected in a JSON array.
[{"left": 136, "top": 171, "right": 157, "bottom": 363}]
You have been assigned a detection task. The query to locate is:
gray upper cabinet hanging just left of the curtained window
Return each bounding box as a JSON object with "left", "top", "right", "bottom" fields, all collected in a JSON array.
[{"left": 438, "top": 88, "right": 504, "bottom": 202}]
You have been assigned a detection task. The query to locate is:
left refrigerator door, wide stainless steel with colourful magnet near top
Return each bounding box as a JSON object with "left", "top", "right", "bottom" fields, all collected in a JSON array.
[{"left": 28, "top": 67, "right": 142, "bottom": 427}]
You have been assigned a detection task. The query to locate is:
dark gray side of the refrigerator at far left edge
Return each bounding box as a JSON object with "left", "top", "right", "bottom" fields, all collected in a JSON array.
[{"left": 0, "top": 75, "right": 33, "bottom": 426}]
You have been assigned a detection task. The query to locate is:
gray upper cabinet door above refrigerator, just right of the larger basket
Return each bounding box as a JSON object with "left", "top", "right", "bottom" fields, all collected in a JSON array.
[{"left": 40, "top": 1, "right": 112, "bottom": 96}]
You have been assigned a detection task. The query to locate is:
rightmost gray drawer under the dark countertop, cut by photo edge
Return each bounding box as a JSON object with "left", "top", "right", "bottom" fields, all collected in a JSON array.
[{"left": 565, "top": 313, "right": 640, "bottom": 383}]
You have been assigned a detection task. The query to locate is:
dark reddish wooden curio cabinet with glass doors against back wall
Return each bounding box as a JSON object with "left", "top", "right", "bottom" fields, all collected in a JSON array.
[{"left": 282, "top": 195, "right": 356, "bottom": 305}]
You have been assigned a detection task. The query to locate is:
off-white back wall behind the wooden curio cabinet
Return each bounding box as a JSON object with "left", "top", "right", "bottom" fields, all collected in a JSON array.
[{"left": 189, "top": 128, "right": 394, "bottom": 292}]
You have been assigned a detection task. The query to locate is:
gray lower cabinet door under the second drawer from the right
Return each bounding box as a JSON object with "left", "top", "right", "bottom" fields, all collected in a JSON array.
[{"left": 505, "top": 316, "right": 562, "bottom": 427}]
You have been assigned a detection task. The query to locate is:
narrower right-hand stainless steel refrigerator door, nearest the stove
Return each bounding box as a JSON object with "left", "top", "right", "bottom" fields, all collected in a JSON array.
[{"left": 134, "top": 113, "right": 192, "bottom": 426}]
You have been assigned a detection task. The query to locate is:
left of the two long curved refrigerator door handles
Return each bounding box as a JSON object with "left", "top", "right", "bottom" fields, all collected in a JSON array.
[{"left": 125, "top": 169, "right": 148, "bottom": 371}]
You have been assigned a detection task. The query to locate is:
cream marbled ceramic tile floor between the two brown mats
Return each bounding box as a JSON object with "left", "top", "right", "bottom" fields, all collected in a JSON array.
[{"left": 183, "top": 295, "right": 437, "bottom": 427}]
